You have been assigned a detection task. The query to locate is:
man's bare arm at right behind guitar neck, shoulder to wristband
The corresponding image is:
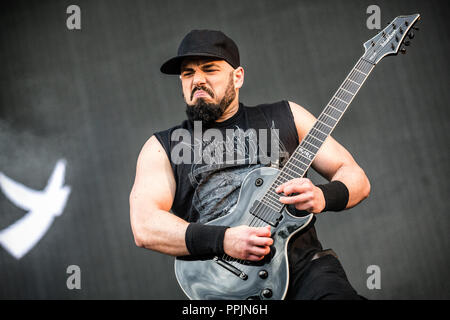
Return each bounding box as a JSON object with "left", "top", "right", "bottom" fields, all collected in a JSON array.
[{"left": 289, "top": 102, "right": 370, "bottom": 212}]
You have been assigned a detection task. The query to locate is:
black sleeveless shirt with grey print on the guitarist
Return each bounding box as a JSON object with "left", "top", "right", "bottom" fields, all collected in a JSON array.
[{"left": 154, "top": 100, "right": 322, "bottom": 268}]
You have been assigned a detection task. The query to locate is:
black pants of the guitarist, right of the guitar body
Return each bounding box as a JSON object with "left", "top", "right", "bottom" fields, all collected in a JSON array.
[{"left": 286, "top": 255, "right": 364, "bottom": 300}]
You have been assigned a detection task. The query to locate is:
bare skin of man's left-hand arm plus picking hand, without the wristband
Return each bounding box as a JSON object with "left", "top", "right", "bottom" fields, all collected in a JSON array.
[{"left": 130, "top": 136, "right": 273, "bottom": 261}]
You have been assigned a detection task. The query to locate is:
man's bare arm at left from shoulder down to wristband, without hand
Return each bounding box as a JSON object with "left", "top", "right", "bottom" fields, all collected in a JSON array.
[{"left": 130, "top": 136, "right": 189, "bottom": 256}]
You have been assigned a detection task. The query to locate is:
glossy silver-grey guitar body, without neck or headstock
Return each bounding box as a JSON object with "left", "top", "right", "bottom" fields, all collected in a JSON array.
[{"left": 175, "top": 167, "right": 313, "bottom": 300}]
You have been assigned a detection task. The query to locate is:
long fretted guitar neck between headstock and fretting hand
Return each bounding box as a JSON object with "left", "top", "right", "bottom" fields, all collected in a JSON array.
[{"left": 261, "top": 55, "right": 375, "bottom": 211}]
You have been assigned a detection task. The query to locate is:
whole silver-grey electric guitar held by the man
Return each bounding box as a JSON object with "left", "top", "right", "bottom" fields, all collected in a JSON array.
[{"left": 175, "top": 14, "right": 420, "bottom": 300}]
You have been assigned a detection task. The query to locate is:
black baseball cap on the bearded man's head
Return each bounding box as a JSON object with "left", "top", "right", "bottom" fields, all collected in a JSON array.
[{"left": 161, "top": 30, "right": 240, "bottom": 74}]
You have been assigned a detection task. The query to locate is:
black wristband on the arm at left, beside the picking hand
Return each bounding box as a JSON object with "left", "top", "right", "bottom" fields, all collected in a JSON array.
[{"left": 185, "top": 223, "right": 229, "bottom": 256}]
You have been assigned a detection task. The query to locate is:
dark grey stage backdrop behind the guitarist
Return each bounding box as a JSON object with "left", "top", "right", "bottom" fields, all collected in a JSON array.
[{"left": 0, "top": 0, "right": 450, "bottom": 299}]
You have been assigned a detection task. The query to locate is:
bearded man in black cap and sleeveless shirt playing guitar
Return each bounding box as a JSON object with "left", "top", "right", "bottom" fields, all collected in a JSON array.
[{"left": 130, "top": 30, "right": 370, "bottom": 299}]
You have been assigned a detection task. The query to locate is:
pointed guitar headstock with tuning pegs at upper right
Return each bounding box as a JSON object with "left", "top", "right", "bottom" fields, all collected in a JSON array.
[{"left": 364, "top": 14, "right": 420, "bottom": 64}]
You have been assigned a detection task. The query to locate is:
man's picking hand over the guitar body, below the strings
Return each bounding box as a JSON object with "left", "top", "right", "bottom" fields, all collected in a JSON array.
[{"left": 223, "top": 225, "right": 273, "bottom": 261}]
